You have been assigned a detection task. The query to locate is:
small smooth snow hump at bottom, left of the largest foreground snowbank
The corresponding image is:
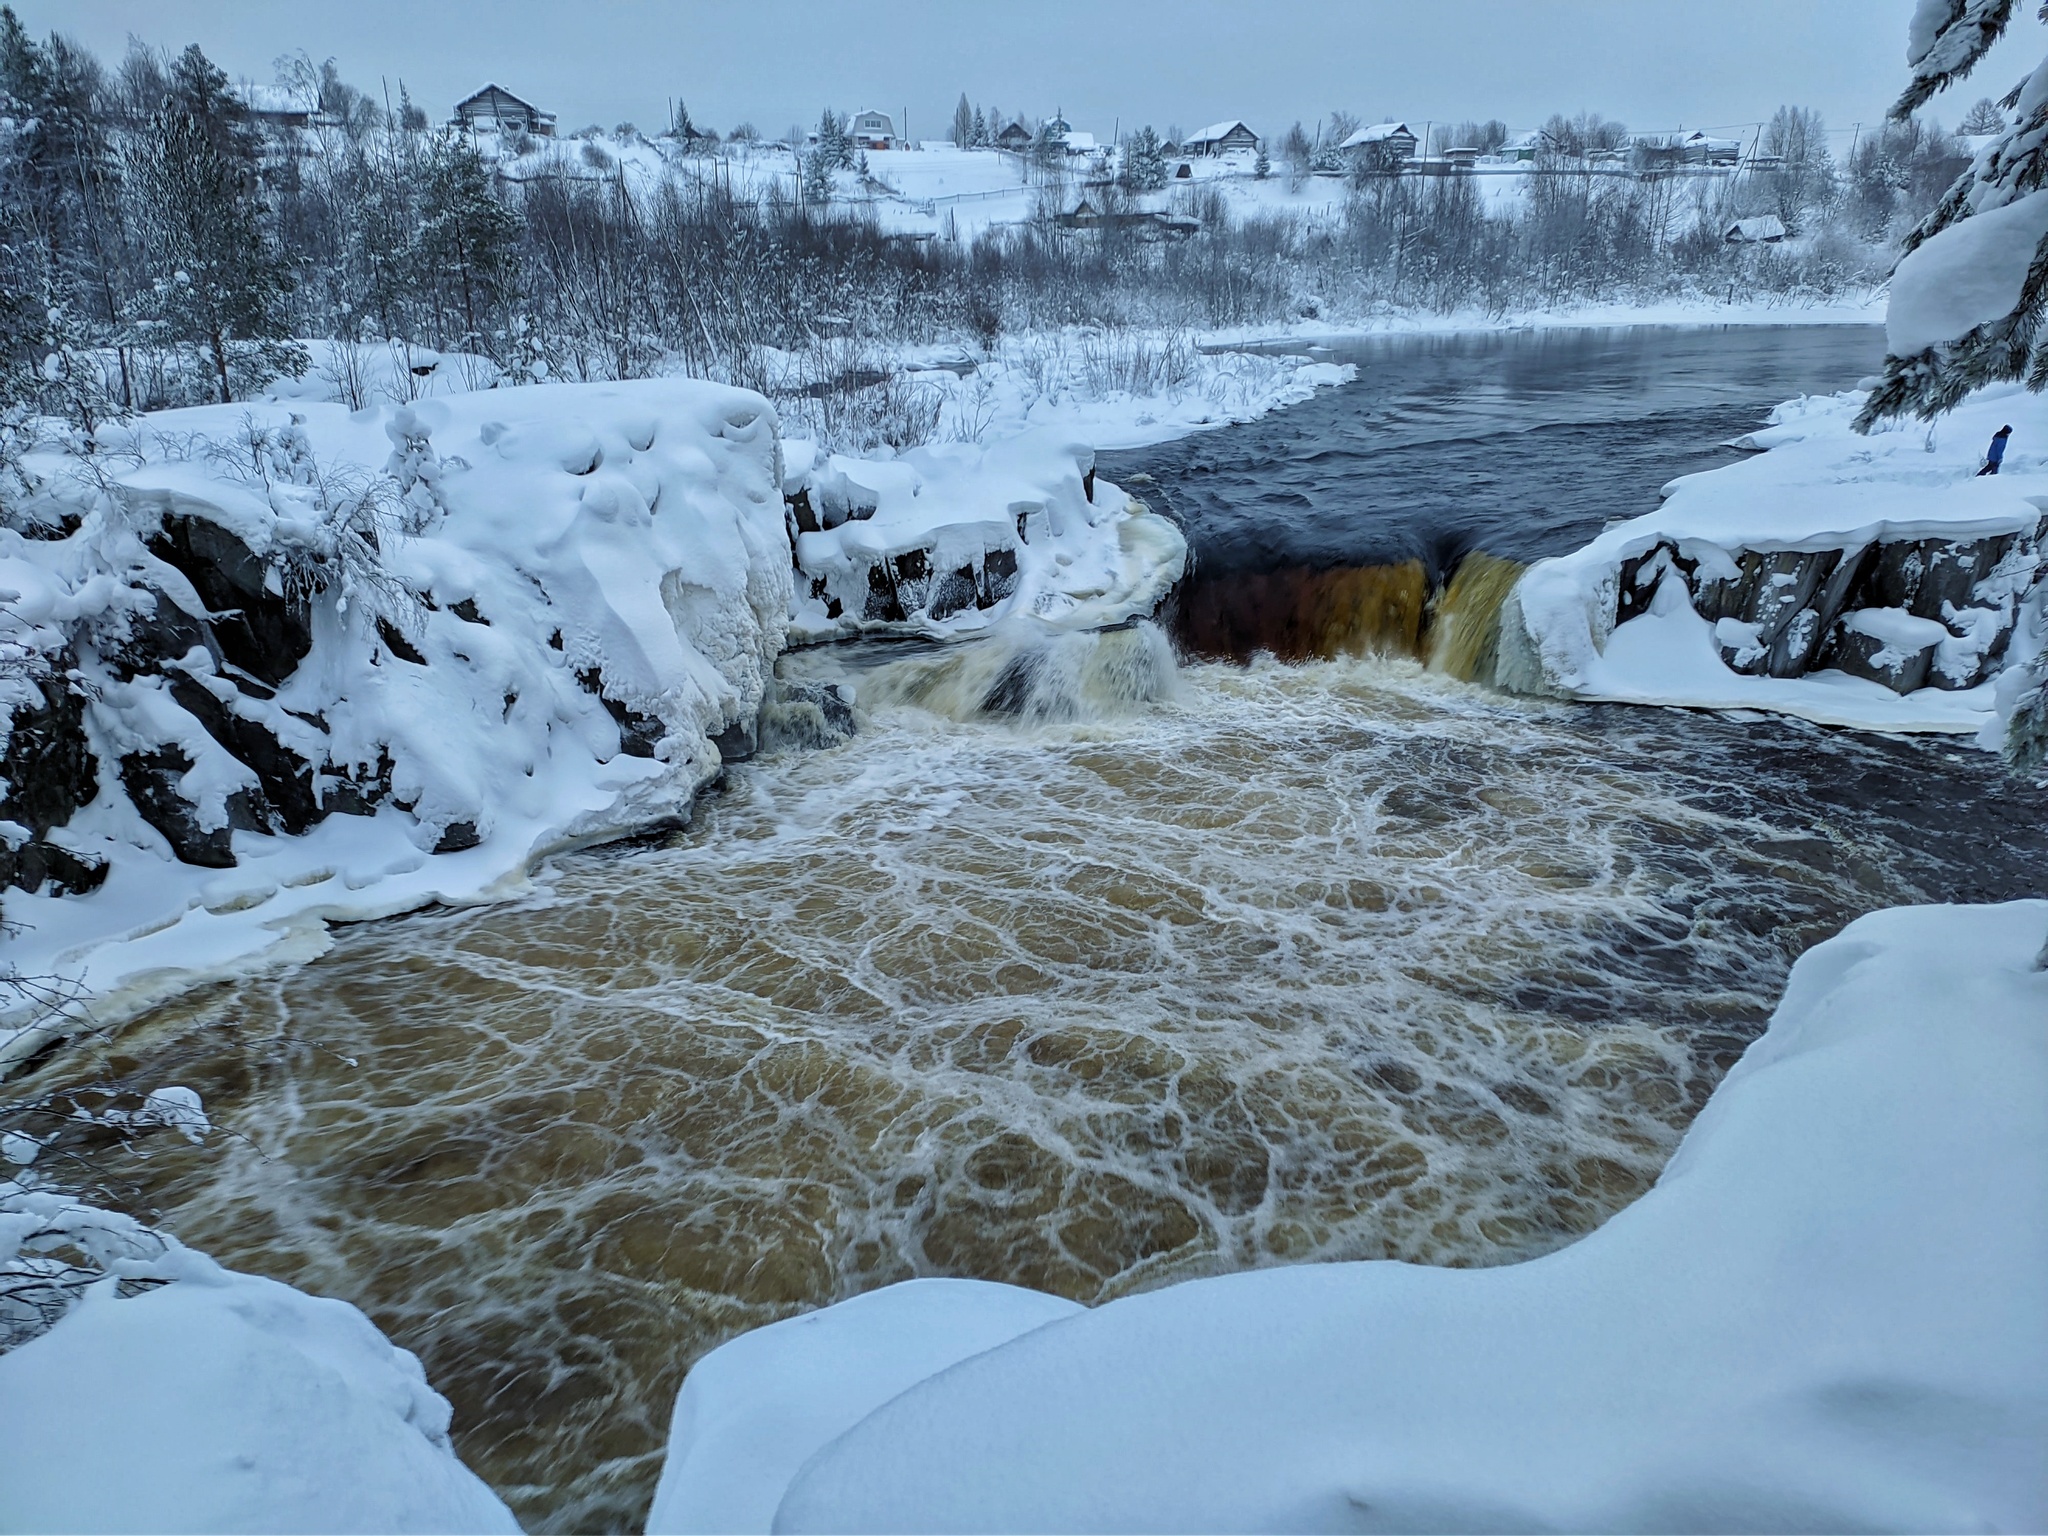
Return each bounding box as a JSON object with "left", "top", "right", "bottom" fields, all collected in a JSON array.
[{"left": 647, "top": 1280, "right": 1081, "bottom": 1536}]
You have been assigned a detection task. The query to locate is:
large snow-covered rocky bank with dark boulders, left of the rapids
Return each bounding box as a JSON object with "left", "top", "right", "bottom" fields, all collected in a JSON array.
[{"left": 0, "top": 381, "right": 793, "bottom": 1057}]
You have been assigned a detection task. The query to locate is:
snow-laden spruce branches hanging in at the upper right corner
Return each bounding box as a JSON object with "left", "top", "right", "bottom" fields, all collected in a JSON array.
[{"left": 1855, "top": 0, "right": 2048, "bottom": 432}]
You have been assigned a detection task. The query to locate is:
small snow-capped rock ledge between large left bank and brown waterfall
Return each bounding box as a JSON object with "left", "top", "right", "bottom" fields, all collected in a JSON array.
[{"left": 784, "top": 432, "right": 1188, "bottom": 641}]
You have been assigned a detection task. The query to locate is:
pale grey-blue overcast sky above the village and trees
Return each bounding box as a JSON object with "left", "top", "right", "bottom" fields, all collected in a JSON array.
[{"left": 12, "top": 0, "right": 2048, "bottom": 147}]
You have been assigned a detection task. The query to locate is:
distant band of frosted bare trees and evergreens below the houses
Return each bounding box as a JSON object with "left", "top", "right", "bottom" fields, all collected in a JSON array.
[{"left": 0, "top": 8, "right": 1966, "bottom": 426}]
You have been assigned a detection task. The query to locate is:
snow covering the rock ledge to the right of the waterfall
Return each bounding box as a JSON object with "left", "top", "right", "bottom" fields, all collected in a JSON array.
[{"left": 1501, "top": 387, "right": 2048, "bottom": 748}]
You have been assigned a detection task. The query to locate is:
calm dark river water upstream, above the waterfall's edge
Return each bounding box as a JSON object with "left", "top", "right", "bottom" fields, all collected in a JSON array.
[{"left": 1122, "top": 326, "right": 1884, "bottom": 580}]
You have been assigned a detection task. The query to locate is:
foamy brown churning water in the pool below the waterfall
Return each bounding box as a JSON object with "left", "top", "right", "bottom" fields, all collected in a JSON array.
[{"left": 16, "top": 321, "right": 2048, "bottom": 1530}]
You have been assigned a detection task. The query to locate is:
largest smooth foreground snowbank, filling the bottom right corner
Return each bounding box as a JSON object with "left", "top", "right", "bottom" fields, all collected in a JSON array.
[{"left": 678, "top": 901, "right": 2048, "bottom": 1530}]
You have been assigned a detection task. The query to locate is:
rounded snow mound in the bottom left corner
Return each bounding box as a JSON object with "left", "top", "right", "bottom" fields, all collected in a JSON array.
[{"left": 0, "top": 1184, "right": 518, "bottom": 1532}]
